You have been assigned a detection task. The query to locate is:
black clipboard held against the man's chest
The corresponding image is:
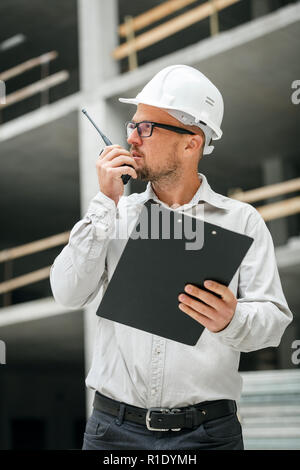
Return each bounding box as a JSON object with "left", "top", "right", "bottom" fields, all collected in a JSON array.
[{"left": 96, "top": 200, "right": 253, "bottom": 346}]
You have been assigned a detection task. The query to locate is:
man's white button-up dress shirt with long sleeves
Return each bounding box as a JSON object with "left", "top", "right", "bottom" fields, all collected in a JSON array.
[{"left": 50, "top": 173, "right": 292, "bottom": 408}]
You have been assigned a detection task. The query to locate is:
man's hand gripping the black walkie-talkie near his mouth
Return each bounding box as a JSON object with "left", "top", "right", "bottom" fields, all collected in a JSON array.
[{"left": 96, "top": 145, "right": 137, "bottom": 206}]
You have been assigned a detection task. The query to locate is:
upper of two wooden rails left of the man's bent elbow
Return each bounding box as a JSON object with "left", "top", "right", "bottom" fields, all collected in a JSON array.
[{"left": 0, "top": 232, "right": 70, "bottom": 263}]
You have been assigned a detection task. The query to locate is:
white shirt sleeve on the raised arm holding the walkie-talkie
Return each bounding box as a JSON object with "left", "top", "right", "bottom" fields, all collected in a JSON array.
[{"left": 50, "top": 191, "right": 117, "bottom": 308}]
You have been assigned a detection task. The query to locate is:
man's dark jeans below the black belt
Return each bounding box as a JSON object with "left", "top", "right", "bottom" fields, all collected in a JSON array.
[{"left": 82, "top": 408, "right": 244, "bottom": 450}]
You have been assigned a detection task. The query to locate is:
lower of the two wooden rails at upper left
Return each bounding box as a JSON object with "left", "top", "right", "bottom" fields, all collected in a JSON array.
[{"left": 0, "top": 70, "right": 69, "bottom": 109}]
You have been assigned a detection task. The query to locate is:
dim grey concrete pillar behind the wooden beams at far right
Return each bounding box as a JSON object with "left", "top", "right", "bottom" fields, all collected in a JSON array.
[{"left": 263, "top": 156, "right": 288, "bottom": 246}]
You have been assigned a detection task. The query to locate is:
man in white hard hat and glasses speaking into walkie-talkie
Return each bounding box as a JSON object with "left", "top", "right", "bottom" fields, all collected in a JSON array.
[{"left": 50, "top": 65, "right": 292, "bottom": 450}]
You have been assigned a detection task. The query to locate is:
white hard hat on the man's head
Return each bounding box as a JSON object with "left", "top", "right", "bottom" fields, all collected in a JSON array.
[{"left": 119, "top": 65, "right": 224, "bottom": 155}]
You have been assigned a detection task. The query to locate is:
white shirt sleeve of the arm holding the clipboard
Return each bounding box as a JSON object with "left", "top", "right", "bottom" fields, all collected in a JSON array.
[{"left": 213, "top": 211, "right": 293, "bottom": 352}]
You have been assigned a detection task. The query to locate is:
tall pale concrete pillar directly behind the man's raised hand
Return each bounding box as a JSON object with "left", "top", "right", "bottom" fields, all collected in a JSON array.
[{"left": 78, "top": 0, "right": 123, "bottom": 416}]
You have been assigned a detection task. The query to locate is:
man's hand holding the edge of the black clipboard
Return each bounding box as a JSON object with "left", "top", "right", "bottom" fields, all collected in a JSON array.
[{"left": 178, "top": 281, "right": 237, "bottom": 333}]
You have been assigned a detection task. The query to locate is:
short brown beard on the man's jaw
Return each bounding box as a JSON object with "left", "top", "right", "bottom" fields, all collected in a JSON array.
[{"left": 136, "top": 144, "right": 181, "bottom": 182}]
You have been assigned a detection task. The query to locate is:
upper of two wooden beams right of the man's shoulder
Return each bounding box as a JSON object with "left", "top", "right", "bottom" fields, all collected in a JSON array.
[{"left": 230, "top": 178, "right": 300, "bottom": 202}]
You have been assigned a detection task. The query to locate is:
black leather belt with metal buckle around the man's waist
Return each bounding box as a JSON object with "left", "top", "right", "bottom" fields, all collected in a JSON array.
[{"left": 93, "top": 392, "right": 237, "bottom": 431}]
